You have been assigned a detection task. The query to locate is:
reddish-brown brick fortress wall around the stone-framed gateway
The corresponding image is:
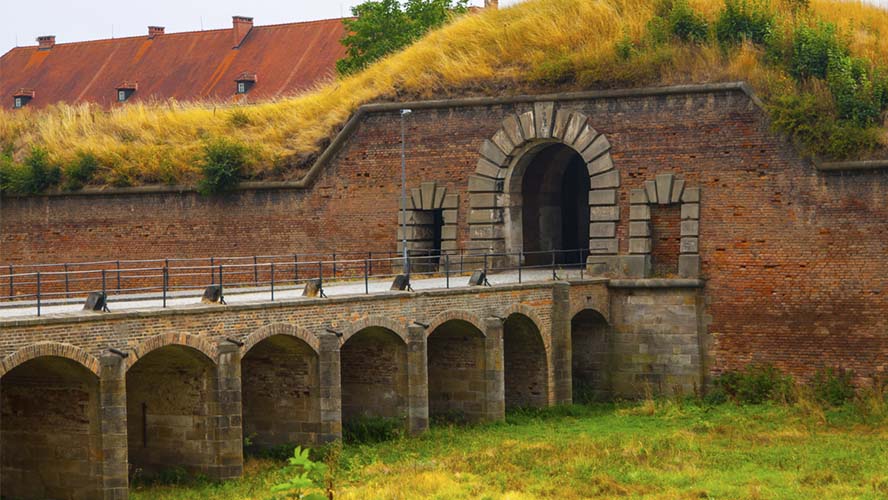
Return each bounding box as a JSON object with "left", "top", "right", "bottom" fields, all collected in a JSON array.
[{"left": 0, "top": 90, "right": 888, "bottom": 377}]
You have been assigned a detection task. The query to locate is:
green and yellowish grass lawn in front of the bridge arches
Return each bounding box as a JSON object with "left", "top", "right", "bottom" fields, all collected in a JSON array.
[{"left": 131, "top": 401, "right": 888, "bottom": 500}]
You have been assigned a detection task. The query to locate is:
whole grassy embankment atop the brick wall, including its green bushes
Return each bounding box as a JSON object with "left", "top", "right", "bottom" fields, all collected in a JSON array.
[{"left": 0, "top": 0, "right": 888, "bottom": 192}]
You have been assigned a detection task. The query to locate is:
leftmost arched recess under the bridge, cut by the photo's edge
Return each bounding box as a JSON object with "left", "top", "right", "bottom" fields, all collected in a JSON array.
[{"left": 0, "top": 356, "right": 102, "bottom": 500}]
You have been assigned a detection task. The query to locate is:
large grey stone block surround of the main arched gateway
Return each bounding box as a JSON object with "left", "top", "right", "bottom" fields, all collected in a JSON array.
[{"left": 469, "top": 101, "right": 620, "bottom": 264}]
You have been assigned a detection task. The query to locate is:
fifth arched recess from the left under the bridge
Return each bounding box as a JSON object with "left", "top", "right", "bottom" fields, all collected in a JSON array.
[{"left": 427, "top": 320, "right": 487, "bottom": 423}]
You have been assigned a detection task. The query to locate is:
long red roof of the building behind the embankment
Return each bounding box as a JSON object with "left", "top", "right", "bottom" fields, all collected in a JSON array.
[{"left": 0, "top": 19, "right": 345, "bottom": 108}]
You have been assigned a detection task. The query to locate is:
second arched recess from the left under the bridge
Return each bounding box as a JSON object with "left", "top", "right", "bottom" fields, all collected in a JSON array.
[{"left": 126, "top": 345, "right": 218, "bottom": 479}]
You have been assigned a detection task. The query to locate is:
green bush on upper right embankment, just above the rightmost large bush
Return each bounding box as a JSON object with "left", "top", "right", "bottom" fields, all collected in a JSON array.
[{"left": 789, "top": 22, "right": 849, "bottom": 80}]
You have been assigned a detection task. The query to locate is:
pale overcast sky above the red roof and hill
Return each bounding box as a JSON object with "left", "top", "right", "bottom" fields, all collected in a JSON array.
[{"left": 0, "top": 0, "right": 520, "bottom": 54}]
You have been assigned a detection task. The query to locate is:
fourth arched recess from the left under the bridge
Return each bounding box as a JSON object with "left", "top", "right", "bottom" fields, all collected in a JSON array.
[{"left": 339, "top": 326, "right": 408, "bottom": 428}]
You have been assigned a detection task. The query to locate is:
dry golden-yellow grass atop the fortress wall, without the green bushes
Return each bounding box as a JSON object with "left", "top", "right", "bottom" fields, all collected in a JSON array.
[{"left": 0, "top": 0, "right": 888, "bottom": 185}]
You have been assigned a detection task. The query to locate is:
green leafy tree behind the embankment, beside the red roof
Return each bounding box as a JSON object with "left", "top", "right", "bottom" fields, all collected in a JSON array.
[{"left": 336, "top": 0, "right": 468, "bottom": 75}]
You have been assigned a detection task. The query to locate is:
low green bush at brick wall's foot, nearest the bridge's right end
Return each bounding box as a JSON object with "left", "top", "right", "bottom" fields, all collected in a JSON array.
[{"left": 715, "top": 364, "right": 795, "bottom": 404}]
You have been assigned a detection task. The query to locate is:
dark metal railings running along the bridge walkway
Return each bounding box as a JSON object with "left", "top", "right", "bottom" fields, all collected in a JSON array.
[{"left": 0, "top": 249, "right": 588, "bottom": 316}]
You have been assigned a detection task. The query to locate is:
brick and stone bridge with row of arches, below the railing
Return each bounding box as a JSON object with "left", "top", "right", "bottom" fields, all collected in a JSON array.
[{"left": 0, "top": 279, "right": 707, "bottom": 499}]
